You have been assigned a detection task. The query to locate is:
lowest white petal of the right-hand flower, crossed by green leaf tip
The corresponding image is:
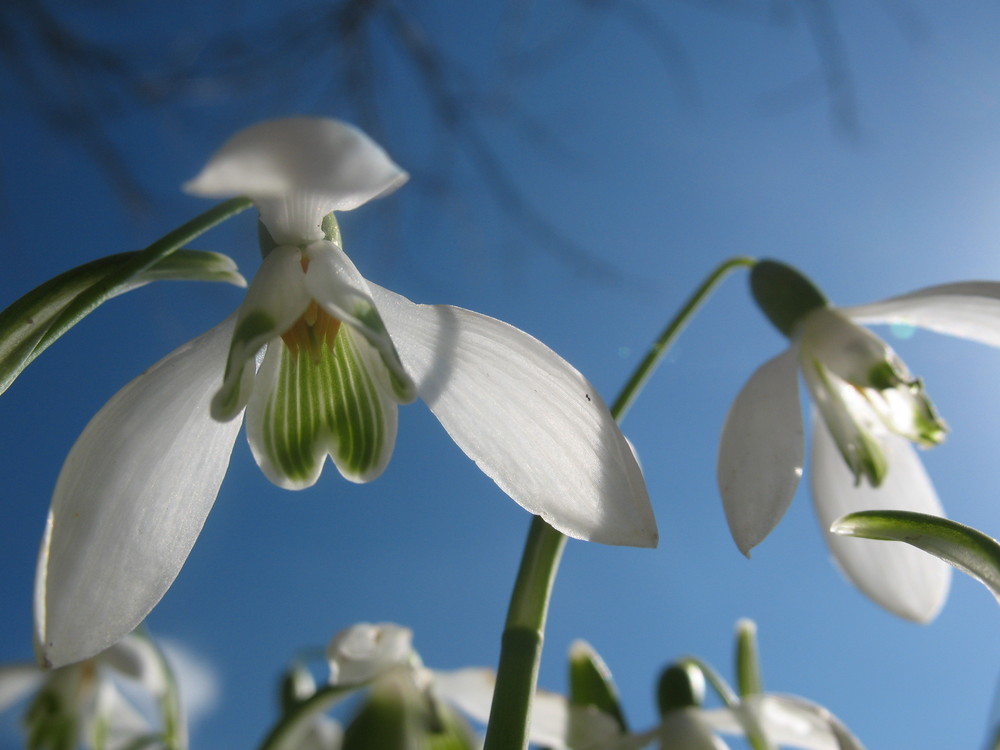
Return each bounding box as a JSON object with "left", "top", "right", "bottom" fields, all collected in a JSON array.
[{"left": 812, "top": 415, "right": 951, "bottom": 622}]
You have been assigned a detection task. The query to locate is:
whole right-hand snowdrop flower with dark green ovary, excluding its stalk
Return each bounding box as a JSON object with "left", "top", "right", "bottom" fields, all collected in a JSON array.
[{"left": 718, "top": 261, "right": 1000, "bottom": 622}]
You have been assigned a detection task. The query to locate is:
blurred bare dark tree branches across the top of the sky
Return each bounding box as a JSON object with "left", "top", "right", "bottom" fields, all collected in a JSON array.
[{"left": 0, "top": 0, "right": 915, "bottom": 279}]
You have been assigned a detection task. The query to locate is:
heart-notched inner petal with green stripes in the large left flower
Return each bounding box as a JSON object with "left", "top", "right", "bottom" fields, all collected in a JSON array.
[{"left": 247, "top": 325, "right": 396, "bottom": 488}]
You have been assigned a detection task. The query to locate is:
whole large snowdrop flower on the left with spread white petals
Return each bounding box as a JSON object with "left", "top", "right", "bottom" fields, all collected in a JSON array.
[{"left": 35, "top": 118, "right": 657, "bottom": 665}]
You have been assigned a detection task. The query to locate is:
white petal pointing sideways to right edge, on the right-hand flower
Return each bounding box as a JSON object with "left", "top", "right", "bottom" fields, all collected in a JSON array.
[{"left": 841, "top": 281, "right": 1000, "bottom": 346}]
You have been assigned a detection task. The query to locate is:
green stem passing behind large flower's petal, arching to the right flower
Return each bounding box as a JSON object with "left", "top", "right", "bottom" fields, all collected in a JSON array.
[{"left": 483, "top": 256, "right": 756, "bottom": 750}]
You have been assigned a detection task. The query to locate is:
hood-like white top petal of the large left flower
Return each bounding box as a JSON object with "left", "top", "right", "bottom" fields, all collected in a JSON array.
[{"left": 184, "top": 117, "right": 408, "bottom": 244}]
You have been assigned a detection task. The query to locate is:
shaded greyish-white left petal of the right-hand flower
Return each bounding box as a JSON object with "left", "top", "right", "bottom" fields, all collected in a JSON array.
[{"left": 716, "top": 347, "right": 805, "bottom": 555}]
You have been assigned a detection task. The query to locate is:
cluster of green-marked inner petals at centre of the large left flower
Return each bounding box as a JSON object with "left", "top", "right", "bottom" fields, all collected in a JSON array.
[{"left": 212, "top": 241, "right": 416, "bottom": 489}]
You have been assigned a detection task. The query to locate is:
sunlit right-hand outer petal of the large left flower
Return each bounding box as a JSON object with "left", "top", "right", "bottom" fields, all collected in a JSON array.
[{"left": 369, "top": 284, "right": 657, "bottom": 547}]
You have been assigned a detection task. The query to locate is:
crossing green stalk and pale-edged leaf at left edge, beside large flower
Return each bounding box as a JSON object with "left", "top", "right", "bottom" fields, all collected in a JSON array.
[{"left": 0, "top": 198, "right": 251, "bottom": 394}]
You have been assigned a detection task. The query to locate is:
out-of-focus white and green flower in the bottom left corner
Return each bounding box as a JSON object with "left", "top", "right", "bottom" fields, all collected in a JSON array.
[{"left": 0, "top": 635, "right": 187, "bottom": 750}]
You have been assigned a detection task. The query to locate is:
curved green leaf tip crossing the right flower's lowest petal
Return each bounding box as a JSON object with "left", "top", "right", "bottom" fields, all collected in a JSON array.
[{"left": 830, "top": 510, "right": 1000, "bottom": 602}]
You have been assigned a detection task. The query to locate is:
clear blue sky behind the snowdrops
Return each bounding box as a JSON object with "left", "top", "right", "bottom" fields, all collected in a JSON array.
[{"left": 0, "top": 0, "right": 1000, "bottom": 750}]
